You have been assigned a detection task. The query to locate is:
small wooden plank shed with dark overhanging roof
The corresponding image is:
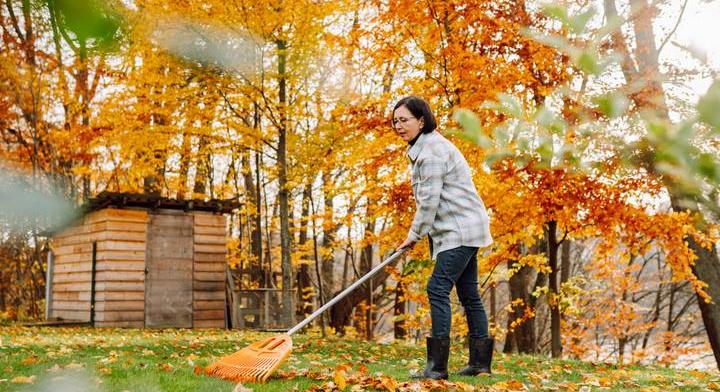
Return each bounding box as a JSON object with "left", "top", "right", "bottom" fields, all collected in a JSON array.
[{"left": 47, "top": 193, "right": 238, "bottom": 328}]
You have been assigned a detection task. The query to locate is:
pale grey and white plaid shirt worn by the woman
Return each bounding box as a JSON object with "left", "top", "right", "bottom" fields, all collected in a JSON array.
[{"left": 407, "top": 131, "right": 493, "bottom": 260}]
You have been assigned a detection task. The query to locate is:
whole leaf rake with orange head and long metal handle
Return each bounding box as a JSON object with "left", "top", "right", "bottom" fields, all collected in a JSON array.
[{"left": 205, "top": 248, "right": 407, "bottom": 382}]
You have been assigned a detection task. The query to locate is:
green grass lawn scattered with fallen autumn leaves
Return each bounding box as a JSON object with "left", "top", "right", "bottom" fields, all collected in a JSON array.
[{"left": 0, "top": 327, "right": 720, "bottom": 392}]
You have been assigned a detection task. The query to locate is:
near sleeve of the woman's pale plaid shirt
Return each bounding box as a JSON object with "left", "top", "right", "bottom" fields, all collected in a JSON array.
[{"left": 407, "top": 156, "right": 445, "bottom": 242}]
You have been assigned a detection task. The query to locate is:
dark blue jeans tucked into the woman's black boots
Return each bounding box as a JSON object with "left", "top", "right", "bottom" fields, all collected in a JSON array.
[{"left": 427, "top": 246, "right": 488, "bottom": 338}]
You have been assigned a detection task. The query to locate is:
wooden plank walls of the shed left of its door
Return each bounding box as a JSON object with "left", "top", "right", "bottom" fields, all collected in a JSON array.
[{"left": 52, "top": 209, "right": 147, "bottom": 327}]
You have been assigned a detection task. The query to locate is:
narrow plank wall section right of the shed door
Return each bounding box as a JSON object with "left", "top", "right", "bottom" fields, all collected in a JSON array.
[{"left": 193, "top": 211, "right": 227, "bottom": 328}]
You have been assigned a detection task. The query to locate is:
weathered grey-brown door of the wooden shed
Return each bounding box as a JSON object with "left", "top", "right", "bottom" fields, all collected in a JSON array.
[{"left": 145, "top": 211, "right": 193, "bottom": 328}]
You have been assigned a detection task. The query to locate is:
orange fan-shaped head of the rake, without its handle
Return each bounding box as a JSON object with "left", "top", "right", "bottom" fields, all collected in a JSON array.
[{"left": 205, "top": 334, "right": 292, "bottom": 382}]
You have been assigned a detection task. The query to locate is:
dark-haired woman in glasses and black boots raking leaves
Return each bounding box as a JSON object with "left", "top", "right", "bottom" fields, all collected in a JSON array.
[{"left": 392, "top": 96, "right": 493, "bottom": 379}]
